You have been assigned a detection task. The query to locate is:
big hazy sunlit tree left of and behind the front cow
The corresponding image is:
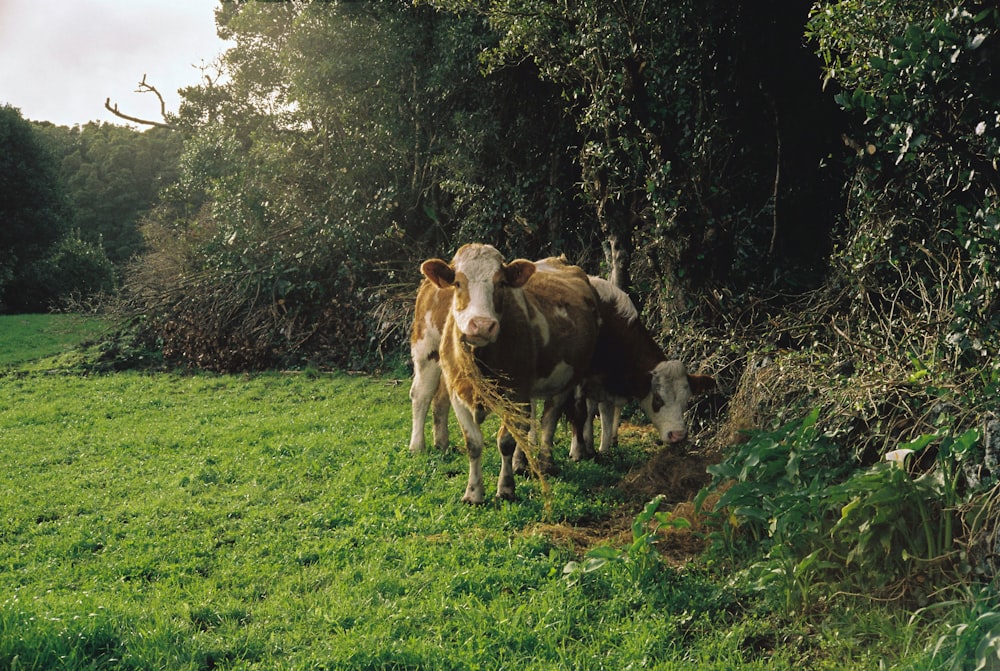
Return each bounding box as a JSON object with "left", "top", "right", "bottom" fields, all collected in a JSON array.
[{"left": 128, "top": 2, "right": 589, "bottom": 368}]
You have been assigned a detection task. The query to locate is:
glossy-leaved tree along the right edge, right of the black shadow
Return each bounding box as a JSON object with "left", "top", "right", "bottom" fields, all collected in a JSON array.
[{"left": 809, "top": 0, "right": 1000, "bottom": 369}]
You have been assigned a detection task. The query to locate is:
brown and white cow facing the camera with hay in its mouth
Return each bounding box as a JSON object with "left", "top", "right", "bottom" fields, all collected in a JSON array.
[{"left": 420, "top": 244, "right": 600, "bottom": 503}]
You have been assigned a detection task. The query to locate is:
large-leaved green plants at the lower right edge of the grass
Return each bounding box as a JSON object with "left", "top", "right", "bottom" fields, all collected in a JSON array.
[{"left": 701, "top": 402, "right": 979, "bottom": 610}]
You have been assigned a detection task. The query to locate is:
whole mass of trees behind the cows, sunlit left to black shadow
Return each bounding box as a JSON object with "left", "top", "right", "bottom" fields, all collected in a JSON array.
[{"left": 117, "top": 2, "right": 839, "bottom": 369}]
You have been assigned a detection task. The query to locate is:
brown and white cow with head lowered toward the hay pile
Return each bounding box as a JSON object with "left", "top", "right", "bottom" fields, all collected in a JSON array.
[{"left": 570, "top": 277, "right": 715, "bottom": 459}]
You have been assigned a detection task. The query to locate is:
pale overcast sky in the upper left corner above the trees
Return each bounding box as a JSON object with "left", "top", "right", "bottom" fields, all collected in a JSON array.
[{"left": 0, "top": 0, "right": 226, "bottom": 126}]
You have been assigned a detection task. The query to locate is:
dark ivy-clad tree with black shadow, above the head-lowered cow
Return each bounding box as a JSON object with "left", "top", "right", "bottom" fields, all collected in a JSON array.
[{"left": 432, "top": 0, "right": 836, "bottom": 314}]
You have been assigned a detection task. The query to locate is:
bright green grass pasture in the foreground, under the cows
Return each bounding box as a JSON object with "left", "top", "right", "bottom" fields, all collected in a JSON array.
[{"left": 0, "top": 320, "right": 936, "bottom": 670}]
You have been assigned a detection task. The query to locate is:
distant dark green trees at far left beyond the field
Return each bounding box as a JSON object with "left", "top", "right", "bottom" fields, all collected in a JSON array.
[{"left": 0, "top": 106, "right": 181, "bottom": 312}]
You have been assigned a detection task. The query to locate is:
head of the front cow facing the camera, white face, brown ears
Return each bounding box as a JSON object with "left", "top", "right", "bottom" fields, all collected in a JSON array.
[{"left": 420, "top": 244, "right": 535, "bottom": 347}]
